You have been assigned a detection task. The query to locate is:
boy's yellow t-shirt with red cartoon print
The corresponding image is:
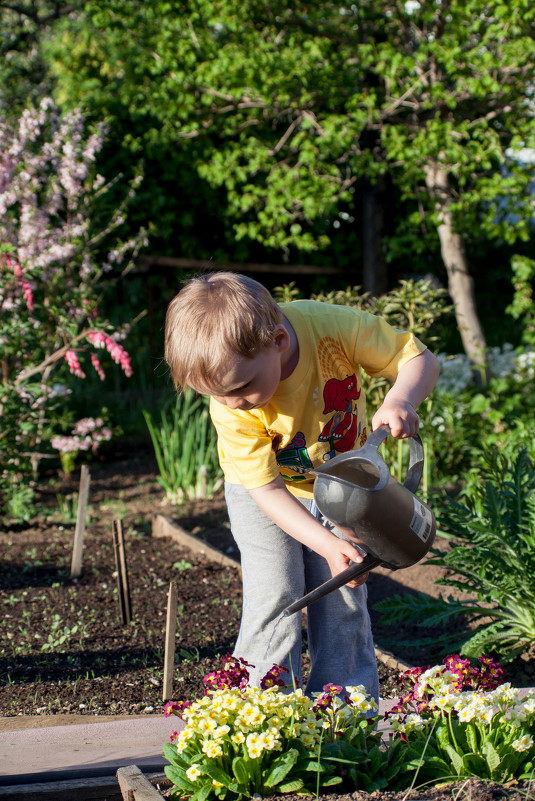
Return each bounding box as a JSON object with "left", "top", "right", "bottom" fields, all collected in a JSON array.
[{"left": 210, "top": 300, "right": 425, "bottom": 498}]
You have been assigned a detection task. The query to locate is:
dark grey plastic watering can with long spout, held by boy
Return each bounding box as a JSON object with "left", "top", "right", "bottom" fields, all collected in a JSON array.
[{"left": 283, "top": 425, "right": 436, "bottom": 616}]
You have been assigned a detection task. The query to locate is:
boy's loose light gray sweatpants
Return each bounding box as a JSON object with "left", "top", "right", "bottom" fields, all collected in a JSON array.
[{"left": 225, "top": 484, "right": 379, "bottom": 700}]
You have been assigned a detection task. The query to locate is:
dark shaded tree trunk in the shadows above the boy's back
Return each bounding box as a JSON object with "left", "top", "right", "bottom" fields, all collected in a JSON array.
[{"left": 362, "top": 176, "right": 388, "bottom": 297}]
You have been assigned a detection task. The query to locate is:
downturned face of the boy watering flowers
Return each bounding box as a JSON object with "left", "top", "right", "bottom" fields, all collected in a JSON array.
[{"left": 197, "top": 326, "right": 289, "bottom": 411}]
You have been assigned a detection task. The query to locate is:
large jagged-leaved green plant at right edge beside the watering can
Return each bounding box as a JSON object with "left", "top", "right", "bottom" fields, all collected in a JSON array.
[{"left": 377, "top": 444, "right": 535, "bottom": 660}]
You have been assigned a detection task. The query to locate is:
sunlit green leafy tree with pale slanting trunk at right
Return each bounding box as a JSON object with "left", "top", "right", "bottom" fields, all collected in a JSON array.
[{"left": 45, "top": 0, "right": 535, "bottom": 370}]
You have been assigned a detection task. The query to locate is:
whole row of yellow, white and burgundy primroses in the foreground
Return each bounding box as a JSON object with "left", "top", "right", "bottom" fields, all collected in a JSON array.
[{"left": 164, "top": 655, "right": 535, "bottom": 801}]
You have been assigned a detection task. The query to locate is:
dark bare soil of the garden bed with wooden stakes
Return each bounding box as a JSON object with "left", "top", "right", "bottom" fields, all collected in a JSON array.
[{"left": 0, "top": 452, "right": 535, "bottom": 801}]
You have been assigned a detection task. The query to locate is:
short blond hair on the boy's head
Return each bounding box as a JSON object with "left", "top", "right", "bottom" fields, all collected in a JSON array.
[{"left": 165, "top": 272, "right": 283, "bottom": 391}]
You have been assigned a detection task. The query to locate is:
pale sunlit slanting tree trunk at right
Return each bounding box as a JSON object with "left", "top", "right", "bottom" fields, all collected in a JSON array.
[{"left": 425, "top": 163, "right": 488, "bottom": 385}]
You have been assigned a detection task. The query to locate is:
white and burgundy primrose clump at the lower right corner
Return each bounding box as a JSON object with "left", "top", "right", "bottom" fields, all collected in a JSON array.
[{"left": 389, "top": 655, "right": 535, "bottom": 788}]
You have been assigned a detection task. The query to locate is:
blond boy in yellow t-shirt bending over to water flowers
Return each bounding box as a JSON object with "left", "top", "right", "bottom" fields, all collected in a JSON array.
[{"left": 165, "top": 272, "right": 439, "bottom": 699}]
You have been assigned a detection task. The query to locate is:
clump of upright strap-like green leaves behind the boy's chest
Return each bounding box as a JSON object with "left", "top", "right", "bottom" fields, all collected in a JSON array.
[{"left": 143, "top": 389, "right": 222, "bottom": 504}]
